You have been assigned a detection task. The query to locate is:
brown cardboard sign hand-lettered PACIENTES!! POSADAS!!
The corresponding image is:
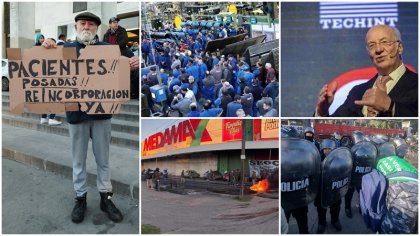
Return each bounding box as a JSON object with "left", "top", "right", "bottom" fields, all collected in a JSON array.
[{"left": 7, "top": 45, "right": 130, "bottom": 114}]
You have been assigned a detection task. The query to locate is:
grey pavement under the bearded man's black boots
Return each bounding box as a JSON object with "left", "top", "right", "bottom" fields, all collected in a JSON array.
[{"left": 2, "top": 158, "right": 139, "bottom": 234}]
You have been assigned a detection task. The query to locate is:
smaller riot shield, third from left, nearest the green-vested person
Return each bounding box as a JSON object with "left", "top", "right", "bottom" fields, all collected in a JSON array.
[{"left": 351, "top": 141, "right": 378, "bottom": 188}]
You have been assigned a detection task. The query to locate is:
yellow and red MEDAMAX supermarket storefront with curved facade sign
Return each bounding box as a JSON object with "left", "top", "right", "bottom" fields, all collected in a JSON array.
[{"left": 141, "top": 119, "right": 279, "bottom": 175}]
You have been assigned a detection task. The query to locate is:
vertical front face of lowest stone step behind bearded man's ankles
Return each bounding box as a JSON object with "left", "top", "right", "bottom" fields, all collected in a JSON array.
[{"left": 2, "top": 147, "right": 139, "bottom": 200}]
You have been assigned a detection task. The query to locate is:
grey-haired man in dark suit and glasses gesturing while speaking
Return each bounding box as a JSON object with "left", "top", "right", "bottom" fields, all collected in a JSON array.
[{"left": 315, "top": 25, "right": 418, "bottom": 117}]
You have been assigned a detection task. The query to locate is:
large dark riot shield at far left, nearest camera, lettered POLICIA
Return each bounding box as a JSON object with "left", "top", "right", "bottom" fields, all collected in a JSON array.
[{"left": 281, "top": 138, "right": 321, "bottom": 211}]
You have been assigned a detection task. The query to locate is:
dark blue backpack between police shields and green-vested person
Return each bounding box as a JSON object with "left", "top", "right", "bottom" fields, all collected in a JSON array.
[{"left": 360, "top": 169, "right": 388, "bottom": 232}]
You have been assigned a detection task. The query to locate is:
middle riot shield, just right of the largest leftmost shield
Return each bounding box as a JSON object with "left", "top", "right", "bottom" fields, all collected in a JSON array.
[{"left": 320, "top": 147, "right": 353, "bottom": 207}]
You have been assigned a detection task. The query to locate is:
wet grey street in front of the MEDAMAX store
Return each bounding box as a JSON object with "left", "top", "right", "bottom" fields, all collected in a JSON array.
[{"left": 141, "top": 182, "right": 279, "bottom": 234}]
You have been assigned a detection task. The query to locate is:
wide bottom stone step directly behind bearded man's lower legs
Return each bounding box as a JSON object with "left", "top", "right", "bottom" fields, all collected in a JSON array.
[{"left": 2, "top": 125, "right": 140, "bottom": 199}]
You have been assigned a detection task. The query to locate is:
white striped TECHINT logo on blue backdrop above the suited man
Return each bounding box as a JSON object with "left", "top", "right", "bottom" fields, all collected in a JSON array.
[{"left": 319, "top": 2, "right": 398, "bottom": 30}]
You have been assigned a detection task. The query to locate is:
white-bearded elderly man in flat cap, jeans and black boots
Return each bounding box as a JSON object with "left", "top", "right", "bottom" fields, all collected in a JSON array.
[{"left": 42, "top": 12, "right": 139, "bottom": 223}]
